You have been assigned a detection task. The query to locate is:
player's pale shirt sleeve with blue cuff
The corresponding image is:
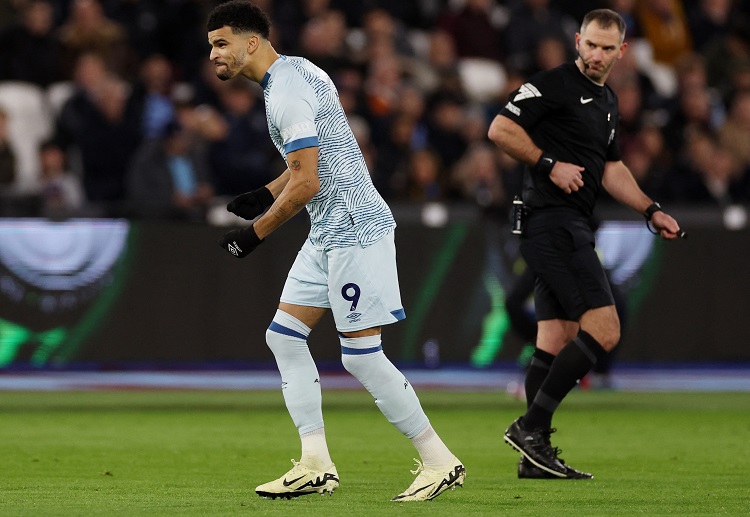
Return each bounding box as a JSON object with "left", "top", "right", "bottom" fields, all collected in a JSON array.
[{"left": 268, "top": 66, "right": 318, "bottom": 154}]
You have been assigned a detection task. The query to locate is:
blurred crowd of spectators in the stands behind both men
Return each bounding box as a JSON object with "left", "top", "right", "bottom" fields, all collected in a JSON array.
[{"left": 0, "top": 0, "right": 750, "bottom": 221}]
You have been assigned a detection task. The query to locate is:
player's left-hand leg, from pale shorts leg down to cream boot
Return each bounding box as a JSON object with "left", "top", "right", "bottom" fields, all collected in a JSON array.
[{"left": 256, "top": 242, "right": 339, "bottom": 498}]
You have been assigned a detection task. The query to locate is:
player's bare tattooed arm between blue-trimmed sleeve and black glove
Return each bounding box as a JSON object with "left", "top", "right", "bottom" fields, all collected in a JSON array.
[{"left": 253, "top": 147, "right": 320, "bottom": 239}]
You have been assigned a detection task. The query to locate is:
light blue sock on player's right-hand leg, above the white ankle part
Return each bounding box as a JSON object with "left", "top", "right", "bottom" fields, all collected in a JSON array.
[{"left": 341, "top": 335, "right": 430, "bottom": 439}]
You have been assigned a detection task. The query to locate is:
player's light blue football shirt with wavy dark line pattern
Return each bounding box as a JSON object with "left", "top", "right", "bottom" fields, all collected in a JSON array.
[{"left": 261, "top": 56, "right": 396, "bottom": 250}]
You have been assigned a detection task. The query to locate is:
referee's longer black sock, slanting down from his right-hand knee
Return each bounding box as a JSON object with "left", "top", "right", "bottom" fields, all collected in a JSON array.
[{"left": 523, "top": 330, "right": 607, "bottom": 429}]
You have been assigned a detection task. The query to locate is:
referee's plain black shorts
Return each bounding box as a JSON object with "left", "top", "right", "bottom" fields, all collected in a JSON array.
[{"left": 521, "top": 207, "right": 615, "bottom": 321}]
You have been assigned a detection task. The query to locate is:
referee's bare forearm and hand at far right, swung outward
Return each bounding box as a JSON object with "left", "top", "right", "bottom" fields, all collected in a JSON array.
[{"left": 602, "top": 161, "right": 680, "bottom": 239}]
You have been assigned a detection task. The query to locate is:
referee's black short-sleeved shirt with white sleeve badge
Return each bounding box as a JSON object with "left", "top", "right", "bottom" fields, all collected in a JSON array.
[{"left": 500, "top": 63, "right": 620, "bottom": 217}]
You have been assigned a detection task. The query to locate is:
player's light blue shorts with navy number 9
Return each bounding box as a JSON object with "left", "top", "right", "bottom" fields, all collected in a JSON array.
[{"left": 281, "top": 232, "right": 406, "bottom": 332}]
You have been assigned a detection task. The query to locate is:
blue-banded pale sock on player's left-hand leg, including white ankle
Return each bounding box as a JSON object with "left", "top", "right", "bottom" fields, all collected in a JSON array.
[{"left": 266, "top": 310, "right": 331, "bottom": 468}]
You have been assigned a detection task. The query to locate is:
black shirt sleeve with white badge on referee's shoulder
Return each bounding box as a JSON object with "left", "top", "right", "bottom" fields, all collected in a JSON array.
[{"left": 500, "top": 72, "right": 563, "bottom": 131}]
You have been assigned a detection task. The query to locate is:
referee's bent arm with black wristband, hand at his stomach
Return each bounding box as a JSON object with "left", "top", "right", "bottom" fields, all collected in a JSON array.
[{"left": 487, "top": 115, "right": 584, "bottom": 194}]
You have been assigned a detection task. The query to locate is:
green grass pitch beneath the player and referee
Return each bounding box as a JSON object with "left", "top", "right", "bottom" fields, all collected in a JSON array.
[{"left": 0, "top": 387, "right": 750, "bottom": 517}]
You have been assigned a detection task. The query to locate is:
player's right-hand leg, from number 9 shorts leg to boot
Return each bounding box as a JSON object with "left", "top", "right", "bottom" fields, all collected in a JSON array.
[{"left": 329, "top": 234, "right": 465, "bottom": 501}]
